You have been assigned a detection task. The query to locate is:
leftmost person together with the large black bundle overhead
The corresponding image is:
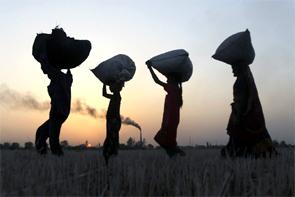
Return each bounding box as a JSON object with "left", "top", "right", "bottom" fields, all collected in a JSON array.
[{"left": 33, "top": 28, "right": 91, "bottom": 156}]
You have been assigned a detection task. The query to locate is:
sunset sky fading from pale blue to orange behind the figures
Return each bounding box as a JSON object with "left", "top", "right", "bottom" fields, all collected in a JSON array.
[{"left": 0, "top": 0, "right": 295, "bottom": 145}]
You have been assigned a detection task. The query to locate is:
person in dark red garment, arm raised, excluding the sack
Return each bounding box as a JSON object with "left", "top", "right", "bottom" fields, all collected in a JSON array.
[{"left": 146, "top": 61, "right": 185, "bottom": 157}]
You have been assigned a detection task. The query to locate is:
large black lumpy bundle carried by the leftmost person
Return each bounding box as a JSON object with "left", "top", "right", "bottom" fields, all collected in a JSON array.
[{"left": 33, "top": 27, "right": 91, "bottom": 69}]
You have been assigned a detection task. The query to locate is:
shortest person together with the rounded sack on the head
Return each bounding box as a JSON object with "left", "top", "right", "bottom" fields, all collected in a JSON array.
[{"left": 91, "top": 54, "right": 136, "bottom": 164}]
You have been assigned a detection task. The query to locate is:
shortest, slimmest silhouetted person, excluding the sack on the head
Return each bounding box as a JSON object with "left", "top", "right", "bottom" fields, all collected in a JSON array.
[{"left": 103, "top": 82, "right": 124, "bottom": 164}]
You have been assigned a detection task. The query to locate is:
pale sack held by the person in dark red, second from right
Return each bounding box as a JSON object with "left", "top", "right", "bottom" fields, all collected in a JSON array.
[{"left": 148, "top": 49, "right": 193, "bottom": 82}]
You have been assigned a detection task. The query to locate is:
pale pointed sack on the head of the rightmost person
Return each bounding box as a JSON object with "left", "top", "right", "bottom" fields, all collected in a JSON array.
[{"left": 212, "top": 29, "right": 255, "bottom": 65}]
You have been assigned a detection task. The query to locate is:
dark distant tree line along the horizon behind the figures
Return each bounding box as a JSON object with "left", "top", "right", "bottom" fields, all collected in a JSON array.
[{"left": 0, "top": 137, "right": 295, "bottom": 150}]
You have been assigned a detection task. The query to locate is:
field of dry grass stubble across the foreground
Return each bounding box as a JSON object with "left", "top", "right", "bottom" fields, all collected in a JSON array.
[{"left": 0, "top": 149, "right": 295, "bottom": 196}]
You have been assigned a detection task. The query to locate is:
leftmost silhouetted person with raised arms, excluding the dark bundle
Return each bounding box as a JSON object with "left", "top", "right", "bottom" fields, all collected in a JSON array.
[{"left": 35, "top": 55, "right": 73, "bottom": 156}]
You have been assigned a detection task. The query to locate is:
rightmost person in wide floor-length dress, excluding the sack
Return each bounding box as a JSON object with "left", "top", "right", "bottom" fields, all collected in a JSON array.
[{"left": 222, "top": 63, "right": 277, "bottom": 157}]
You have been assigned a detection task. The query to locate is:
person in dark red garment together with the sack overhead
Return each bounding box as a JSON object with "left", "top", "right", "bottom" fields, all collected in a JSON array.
[{"left": 146, "top": 49, "right": 193, "bottom": 157}]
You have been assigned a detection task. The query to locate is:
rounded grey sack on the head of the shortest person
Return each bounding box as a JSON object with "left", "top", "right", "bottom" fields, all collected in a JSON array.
[{"left": 91, "top": 54, "right": 136, "bottom": 85}]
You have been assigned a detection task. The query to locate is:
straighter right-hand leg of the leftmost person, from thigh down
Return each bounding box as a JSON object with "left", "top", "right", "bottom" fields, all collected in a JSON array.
[{"left": 49, "top": 117, "right": 64, "bottom": 156}]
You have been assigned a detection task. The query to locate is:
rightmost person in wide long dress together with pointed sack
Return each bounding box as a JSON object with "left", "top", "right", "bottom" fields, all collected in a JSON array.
[{"left": 213, "top": 30, "right": 276, "bottom": 157}]
